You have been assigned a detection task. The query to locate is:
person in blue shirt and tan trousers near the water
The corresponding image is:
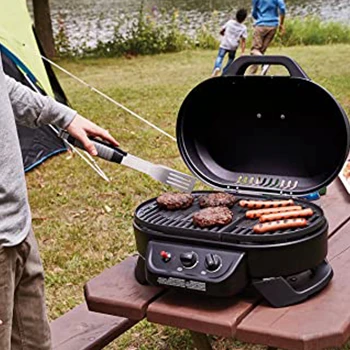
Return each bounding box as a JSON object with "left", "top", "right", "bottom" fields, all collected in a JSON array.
[{"left": 250, "top": 0, "right": 286, "bottom": 74}]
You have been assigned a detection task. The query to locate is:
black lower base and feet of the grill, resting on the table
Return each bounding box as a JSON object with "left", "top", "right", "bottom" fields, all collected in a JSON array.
[{"left": 135, "top": 247, "right": 333, "bottom": 307}]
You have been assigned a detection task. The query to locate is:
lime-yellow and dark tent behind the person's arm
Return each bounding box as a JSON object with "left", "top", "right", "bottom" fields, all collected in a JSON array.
[{"left": 0, "top": 0, "right": 68, "bottom": 171}]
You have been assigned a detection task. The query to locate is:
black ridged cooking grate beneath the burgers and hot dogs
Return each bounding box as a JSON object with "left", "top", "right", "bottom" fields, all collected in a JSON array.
[{"left": 135, "top": 192, "right": 324, "bottom": 244}]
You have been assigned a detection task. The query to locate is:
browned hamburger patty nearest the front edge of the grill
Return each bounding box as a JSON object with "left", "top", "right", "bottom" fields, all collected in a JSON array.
[{"left": 192, "top": 207, "right": 233, "bottom": 228}]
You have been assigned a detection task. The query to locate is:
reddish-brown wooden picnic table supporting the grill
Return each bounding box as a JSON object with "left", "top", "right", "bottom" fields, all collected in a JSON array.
[{"left": 85, "top": 179, "right": 350, "bottom": 350}]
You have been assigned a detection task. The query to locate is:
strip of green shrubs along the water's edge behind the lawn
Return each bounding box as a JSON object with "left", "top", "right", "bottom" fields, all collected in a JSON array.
[{"left": 55, "top": 1, "right": 350, "bottom": 57}]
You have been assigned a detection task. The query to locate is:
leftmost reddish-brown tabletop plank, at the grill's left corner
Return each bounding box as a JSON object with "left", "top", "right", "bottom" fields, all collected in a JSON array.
[{"left": 85, "top": 257, "right": 163, "bottom": 320}]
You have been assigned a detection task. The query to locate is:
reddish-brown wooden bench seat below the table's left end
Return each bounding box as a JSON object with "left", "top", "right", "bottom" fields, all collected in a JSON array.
[{"left": 50, "top": 303, "right": 137, "bottom": 350}]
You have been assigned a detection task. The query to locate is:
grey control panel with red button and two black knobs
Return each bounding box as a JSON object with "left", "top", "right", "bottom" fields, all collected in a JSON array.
[{"left": 146, "top": 241, "right": 245, "bottom": 292}]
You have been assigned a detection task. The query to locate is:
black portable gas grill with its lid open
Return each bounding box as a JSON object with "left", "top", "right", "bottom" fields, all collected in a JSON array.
[{"left": 134, "top": 56, "right": 349, "bottom": 307}]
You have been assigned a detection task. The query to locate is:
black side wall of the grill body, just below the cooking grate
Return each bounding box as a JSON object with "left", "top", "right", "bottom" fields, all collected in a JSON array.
[{"left": 134, "top": 219, "right": 328, "bottom": 278}]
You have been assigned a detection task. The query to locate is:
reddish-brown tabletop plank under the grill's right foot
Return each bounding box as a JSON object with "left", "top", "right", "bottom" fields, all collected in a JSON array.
[{"left": 236, "top": 222, "right": 350, "bottom": 350}]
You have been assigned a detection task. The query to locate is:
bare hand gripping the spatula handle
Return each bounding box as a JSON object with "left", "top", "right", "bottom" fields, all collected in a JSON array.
[{"left": 67, "top": 115, "right": 119, "bottom": 156}]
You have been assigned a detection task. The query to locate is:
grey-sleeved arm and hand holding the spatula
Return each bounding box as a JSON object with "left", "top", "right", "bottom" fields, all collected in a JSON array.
[{"left": 5, "top": 75, "right": 118, "bottom": 155}]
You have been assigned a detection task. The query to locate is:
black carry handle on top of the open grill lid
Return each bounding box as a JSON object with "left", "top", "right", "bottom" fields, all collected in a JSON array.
[{"left": 225, "top": 56, "right": 310, "bottom": 80}]
